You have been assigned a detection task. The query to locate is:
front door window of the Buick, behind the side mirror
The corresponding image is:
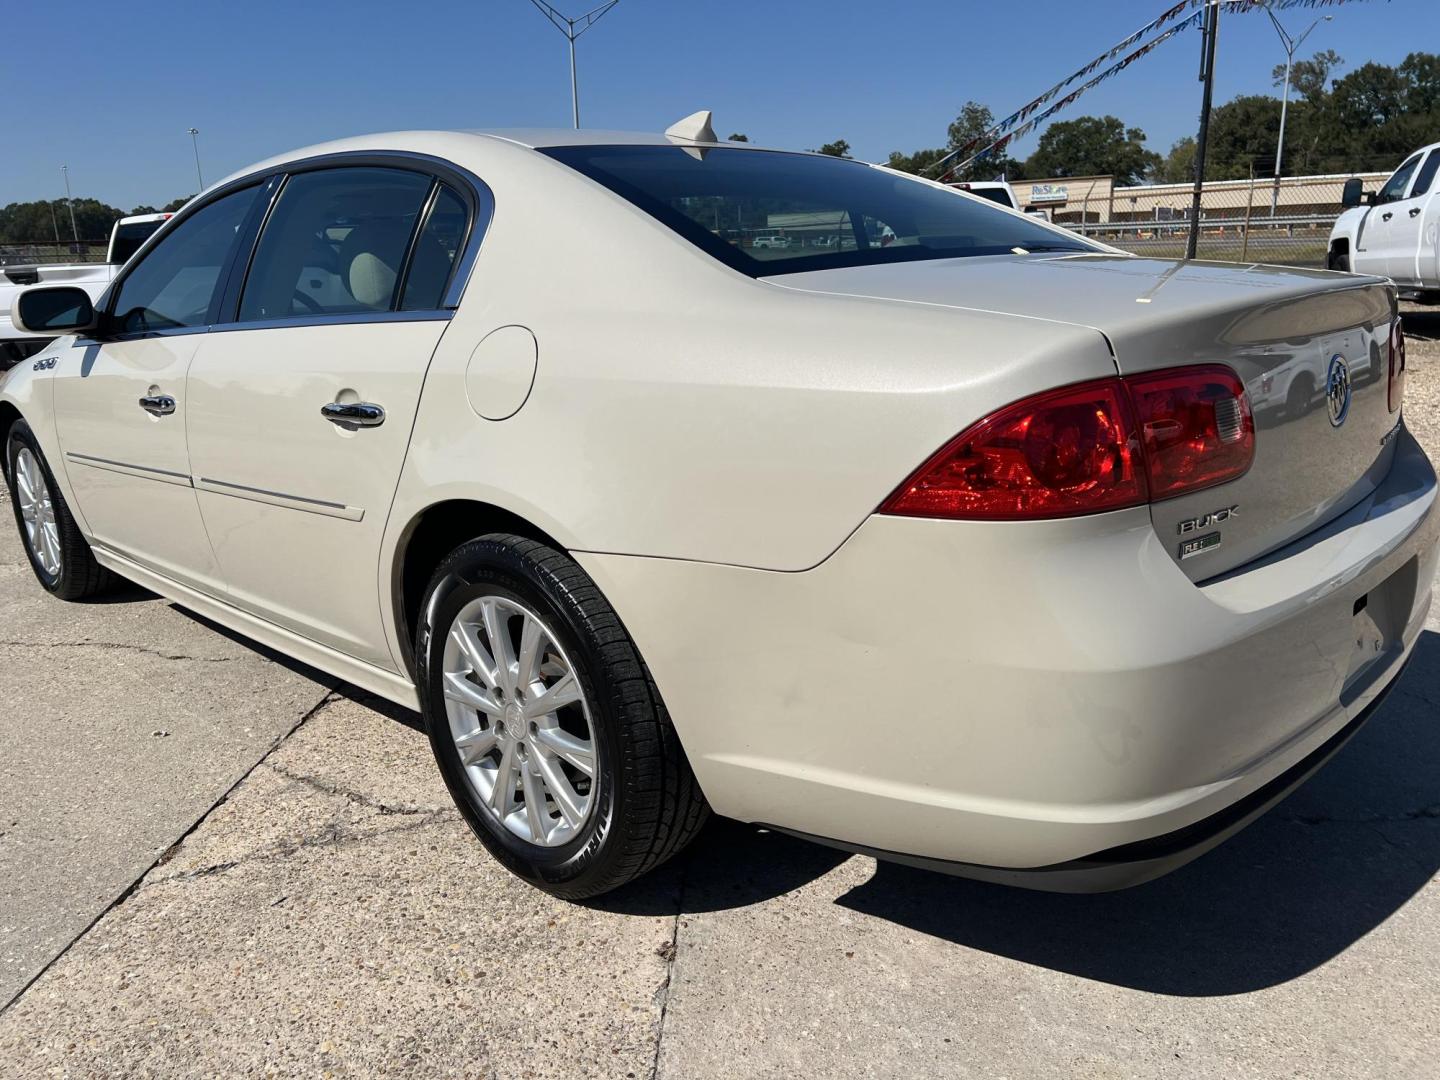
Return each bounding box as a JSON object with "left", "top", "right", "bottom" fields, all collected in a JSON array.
[{"left": 111, "top": 184, "right": 259, "bottom": 334}]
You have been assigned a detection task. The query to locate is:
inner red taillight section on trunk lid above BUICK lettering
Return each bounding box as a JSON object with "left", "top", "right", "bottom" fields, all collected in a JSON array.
[{"left": 1125, "top": 366, "right": 1256, "bottom": 500}]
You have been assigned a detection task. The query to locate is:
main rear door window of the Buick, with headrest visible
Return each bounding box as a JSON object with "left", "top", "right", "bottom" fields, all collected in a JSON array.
[{"left": 239, "top": 167, "right": 432, "bottom": 323}]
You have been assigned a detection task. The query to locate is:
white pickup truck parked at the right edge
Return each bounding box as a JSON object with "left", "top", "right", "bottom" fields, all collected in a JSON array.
[{"left": 1328, "top": 143, "right": 1440, "bottom": 304}]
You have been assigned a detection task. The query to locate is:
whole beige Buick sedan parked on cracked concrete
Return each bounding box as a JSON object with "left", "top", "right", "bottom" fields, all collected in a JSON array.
[{"left": 0, "top": 122, "right": 1440, "bottom": 897}]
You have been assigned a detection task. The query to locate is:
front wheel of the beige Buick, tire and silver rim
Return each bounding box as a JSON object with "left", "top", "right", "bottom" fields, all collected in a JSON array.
[{"left": 4, "top": 420, "right": 114, "bottom": 600}]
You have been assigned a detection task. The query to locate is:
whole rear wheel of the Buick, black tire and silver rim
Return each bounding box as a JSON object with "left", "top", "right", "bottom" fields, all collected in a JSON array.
[{"left": 416, "top": 534, "right": 708, "bottom": 900}]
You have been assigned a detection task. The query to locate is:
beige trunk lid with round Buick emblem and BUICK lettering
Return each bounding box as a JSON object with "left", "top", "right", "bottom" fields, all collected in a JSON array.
[{"left": 769, "top": 253, "right": 1400, "bottom": 582}]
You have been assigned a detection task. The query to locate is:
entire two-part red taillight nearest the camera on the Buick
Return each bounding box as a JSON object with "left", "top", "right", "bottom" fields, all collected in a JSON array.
[{"left": 880, "top": 366, "right": 1256, "bottom": 521}]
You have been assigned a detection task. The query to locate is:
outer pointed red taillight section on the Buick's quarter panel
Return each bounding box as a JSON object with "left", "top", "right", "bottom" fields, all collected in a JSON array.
[{"left": 880, "top": 379, "right": 1146, "bottom": 520}]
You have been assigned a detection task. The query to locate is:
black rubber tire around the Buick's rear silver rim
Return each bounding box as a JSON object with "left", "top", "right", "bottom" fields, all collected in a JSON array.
[{"left": 416, "top": 533, "right": 708, "bottom": 900}]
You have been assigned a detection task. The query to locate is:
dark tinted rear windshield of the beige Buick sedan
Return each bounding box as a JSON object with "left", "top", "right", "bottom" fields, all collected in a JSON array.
[{"left": 543, "top": 145, "right": 1096, "bottom": 276}]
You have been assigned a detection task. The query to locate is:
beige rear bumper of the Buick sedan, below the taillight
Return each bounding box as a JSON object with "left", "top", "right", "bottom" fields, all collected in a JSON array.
[{"left": 576, "top": 433, "right": 1440, "bottom": 887}]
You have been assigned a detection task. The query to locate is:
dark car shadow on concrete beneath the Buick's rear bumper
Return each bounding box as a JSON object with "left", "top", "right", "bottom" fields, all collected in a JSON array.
[{"left": 596, "top": 632, "right": 1440, "bottom": 996}]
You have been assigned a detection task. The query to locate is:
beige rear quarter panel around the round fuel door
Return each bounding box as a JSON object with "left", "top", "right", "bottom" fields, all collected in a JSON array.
[{"left": 387, "top": 141, "right": 1115, "bottom": 570}]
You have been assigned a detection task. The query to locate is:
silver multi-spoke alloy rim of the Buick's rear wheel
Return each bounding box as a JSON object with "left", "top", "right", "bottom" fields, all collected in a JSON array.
[{"left": 442, "top": 596, "right": 599, "bottom": 847}]
